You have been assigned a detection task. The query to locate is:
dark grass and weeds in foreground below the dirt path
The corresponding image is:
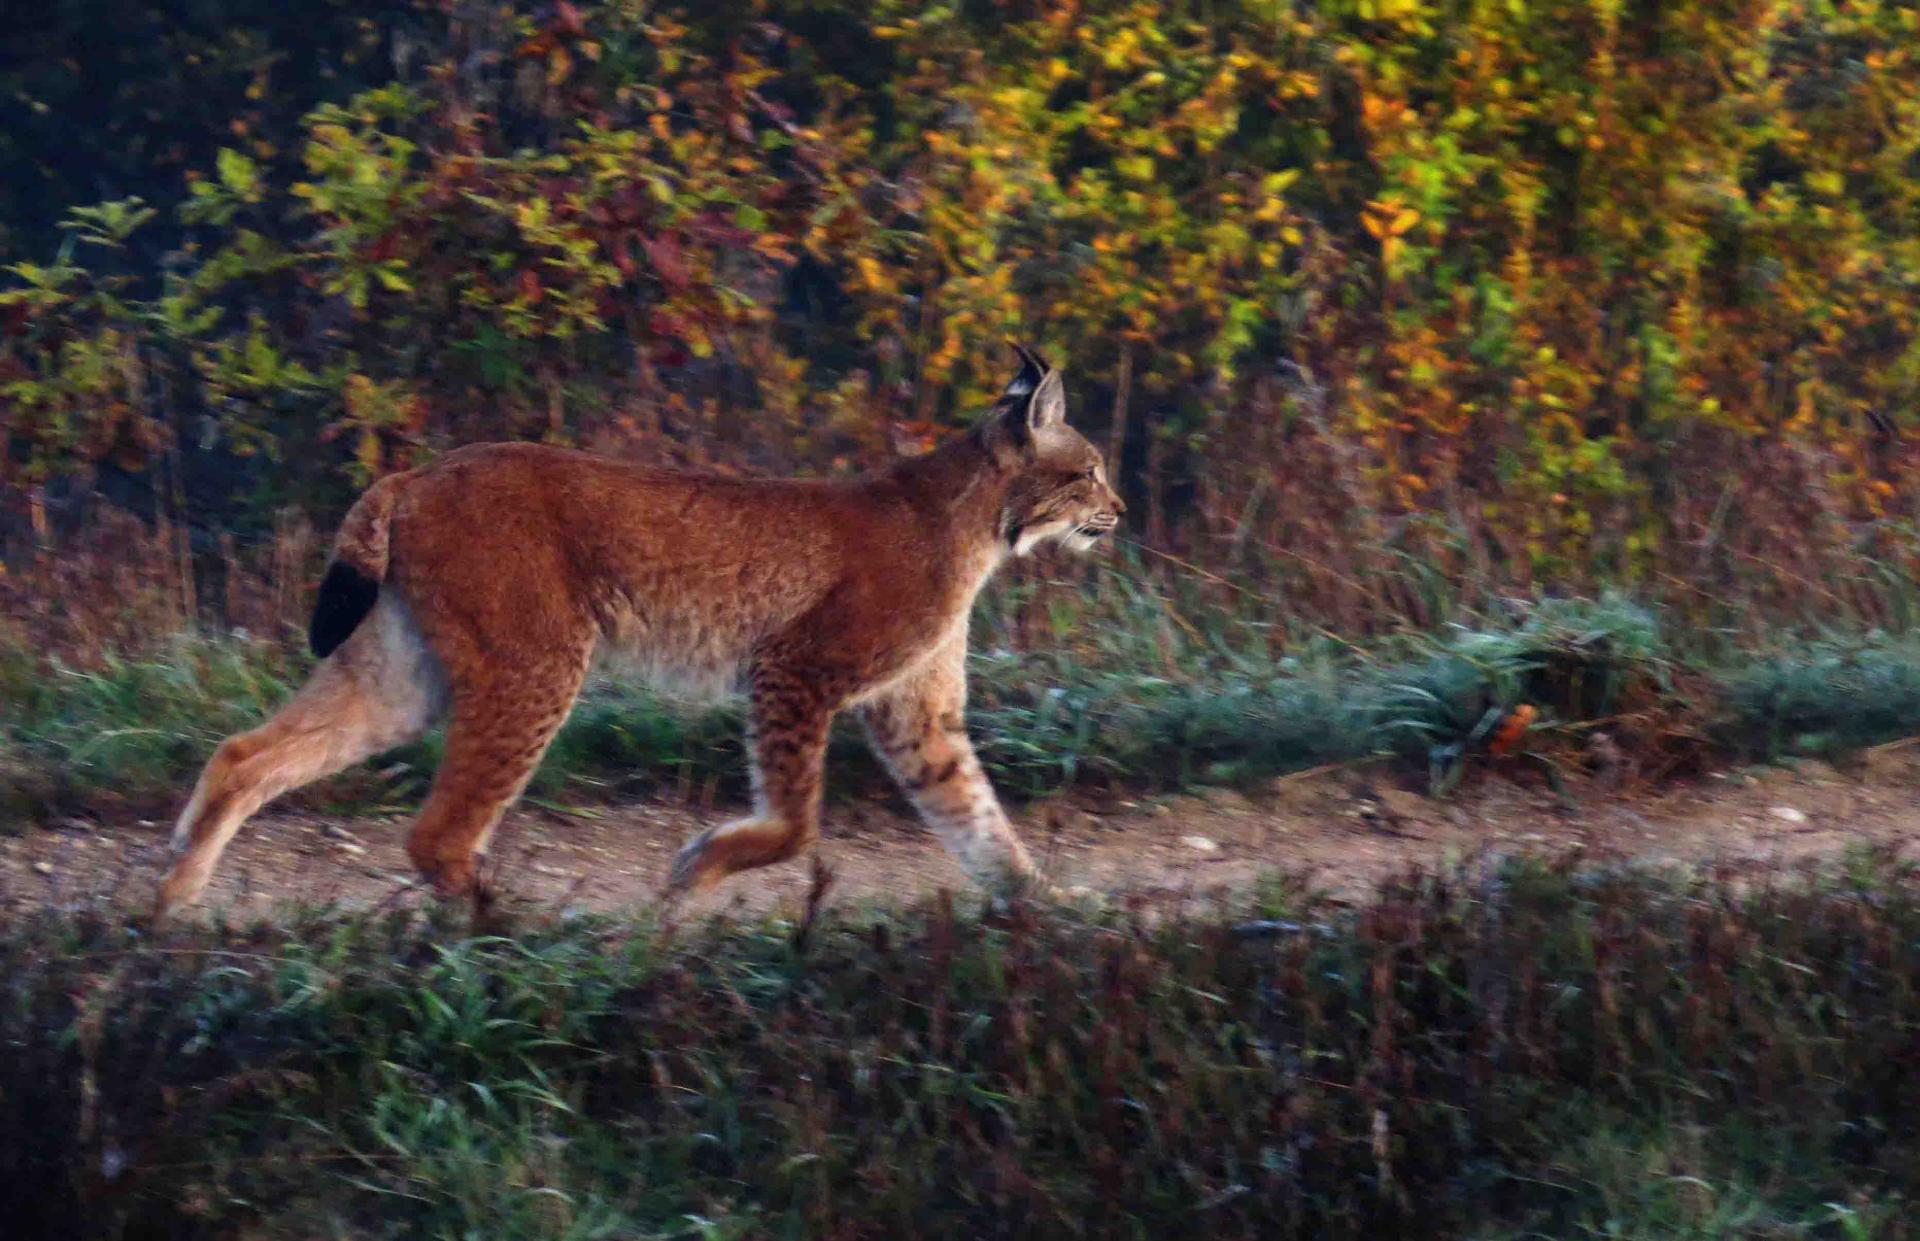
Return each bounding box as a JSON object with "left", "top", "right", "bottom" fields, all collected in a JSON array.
[{"left": 0, "top": 859, "right": 1920, "bottom": 1241}]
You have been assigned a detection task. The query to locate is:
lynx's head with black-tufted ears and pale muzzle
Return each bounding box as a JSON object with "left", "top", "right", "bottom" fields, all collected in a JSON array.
[{"left": 981, "top": 346, "right": 1127, "bottom": 555}]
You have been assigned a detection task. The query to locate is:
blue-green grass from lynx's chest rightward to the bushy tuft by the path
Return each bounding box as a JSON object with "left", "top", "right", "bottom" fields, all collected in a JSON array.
[{"left": 973, "top": 596, "right": 1672, "bottom": 795}]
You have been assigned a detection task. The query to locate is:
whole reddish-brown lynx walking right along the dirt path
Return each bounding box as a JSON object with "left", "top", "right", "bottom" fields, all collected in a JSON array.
[{"left": 156, "top": 348, "right": 1125, "bottom": 916}]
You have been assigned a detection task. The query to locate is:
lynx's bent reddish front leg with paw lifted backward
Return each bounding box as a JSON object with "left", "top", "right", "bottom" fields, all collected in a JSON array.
[{"left": 666, "top": 674, "right": 833, "bottom": 895}]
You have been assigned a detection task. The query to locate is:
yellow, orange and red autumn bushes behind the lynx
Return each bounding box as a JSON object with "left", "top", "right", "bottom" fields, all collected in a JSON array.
[{"left": 0, "top": 0, "right": 1920, "bottom": 628}]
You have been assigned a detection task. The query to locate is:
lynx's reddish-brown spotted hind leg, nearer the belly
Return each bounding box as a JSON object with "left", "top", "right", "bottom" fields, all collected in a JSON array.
[{"left": 407, "top": 653, "right": 591, "bottom": 897}]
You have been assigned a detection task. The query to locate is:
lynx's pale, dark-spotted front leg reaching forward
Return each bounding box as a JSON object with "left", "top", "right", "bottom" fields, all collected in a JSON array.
[{"left": 862, "top": 644, "right": 1044, "bottom": 895}]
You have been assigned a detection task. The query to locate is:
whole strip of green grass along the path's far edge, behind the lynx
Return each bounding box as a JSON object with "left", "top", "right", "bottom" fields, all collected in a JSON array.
[{"left": 11, "top": 572, "right": 1920, "bottom": 822}]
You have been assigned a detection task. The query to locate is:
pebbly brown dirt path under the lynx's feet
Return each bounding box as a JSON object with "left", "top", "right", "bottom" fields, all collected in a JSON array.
[{"left": 0, "top": 747, "right": 1920, "bottom": 918}]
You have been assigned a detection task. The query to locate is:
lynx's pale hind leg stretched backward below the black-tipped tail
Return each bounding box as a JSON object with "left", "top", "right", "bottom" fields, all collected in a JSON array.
[{"left": 154, "top": 607, "right": 442, "bottom": 918}]
